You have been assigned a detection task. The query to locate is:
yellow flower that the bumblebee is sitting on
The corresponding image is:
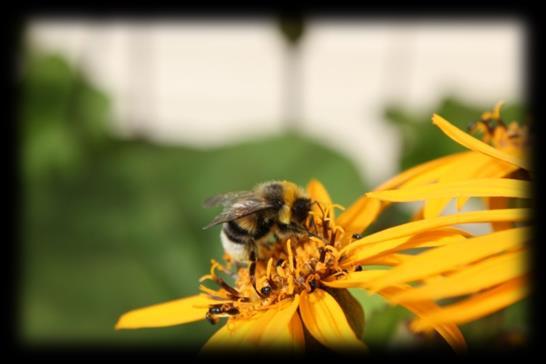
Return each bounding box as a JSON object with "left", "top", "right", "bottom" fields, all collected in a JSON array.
[{"left": 116, "top": 181, "right": 464, "bottom": 350}]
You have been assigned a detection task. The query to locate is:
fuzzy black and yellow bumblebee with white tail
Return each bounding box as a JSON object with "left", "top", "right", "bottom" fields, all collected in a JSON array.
[{"left": 204, "top": 181, "right": 312, "bottom": 262}]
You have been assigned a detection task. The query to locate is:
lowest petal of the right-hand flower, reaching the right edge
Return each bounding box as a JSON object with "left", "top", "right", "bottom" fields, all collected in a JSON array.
[{"left": 411, "top": 277, "right": 528, "bottom": 331}]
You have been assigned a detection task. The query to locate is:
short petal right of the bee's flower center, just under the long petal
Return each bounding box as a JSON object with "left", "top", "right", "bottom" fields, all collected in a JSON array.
[{"left": 341, "top": 228, "right": 469, "bottom": 268}]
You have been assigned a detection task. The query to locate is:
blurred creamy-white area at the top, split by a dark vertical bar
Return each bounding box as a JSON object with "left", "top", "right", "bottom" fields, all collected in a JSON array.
[{"left": 28, "top": 19, "right": 525, "bottom": 183}]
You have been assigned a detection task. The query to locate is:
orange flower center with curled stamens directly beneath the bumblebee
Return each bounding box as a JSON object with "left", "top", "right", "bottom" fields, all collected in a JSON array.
[{"left": 201, "top": 206, "right": 352, "bottom": 323}]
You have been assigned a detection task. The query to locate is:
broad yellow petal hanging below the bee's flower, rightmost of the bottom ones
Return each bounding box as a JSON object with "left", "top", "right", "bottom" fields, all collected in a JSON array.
[{"left": 300, "top": 289, "right": 366, "bottom": 351}]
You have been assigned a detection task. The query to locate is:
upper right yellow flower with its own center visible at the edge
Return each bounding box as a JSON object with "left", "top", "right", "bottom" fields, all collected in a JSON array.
[{"left": 362, "top": 102, "right": 529, "bottom": 223}]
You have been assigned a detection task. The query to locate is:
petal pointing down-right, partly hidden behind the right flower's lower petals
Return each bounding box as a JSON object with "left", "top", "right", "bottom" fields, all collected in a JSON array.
[{"left": 379, "top": 285, "right": 466, "bottom": 351}]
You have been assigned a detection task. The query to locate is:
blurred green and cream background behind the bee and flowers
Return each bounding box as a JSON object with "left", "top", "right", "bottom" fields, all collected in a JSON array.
[{"left": 17, "top": 17, "right": 527, "bottom": 347}]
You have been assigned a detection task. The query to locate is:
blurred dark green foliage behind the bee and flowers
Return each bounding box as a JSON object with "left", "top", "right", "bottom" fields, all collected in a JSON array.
[{"left": 18, "top": 52, "right": 526, "bottom": 347}]
